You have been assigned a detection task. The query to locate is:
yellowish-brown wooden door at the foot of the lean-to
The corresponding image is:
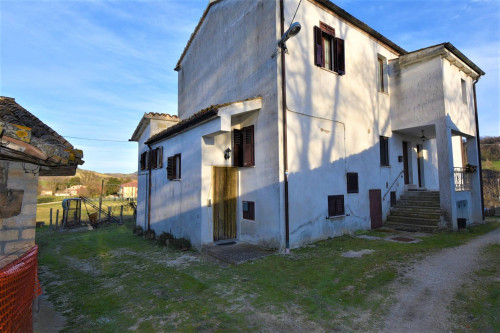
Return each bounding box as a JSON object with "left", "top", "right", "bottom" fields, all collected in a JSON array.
[{"left": 212, "top": 167, "right": 238, "bottom": 241}]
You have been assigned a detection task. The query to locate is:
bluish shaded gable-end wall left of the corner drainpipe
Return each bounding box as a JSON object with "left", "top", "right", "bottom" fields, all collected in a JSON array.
[{"left": 179, "top": 0, "right": 282, "bottom": 247}]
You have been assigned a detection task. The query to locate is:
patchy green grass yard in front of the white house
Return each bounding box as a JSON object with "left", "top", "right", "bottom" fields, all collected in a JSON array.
[{"left": 37, "top": 222, "right": 500, "bottom": 332}]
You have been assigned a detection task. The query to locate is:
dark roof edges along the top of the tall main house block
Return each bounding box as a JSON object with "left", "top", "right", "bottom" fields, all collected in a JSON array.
[{"left": 174, "top": 0, "right": 407, "bottom": 71}]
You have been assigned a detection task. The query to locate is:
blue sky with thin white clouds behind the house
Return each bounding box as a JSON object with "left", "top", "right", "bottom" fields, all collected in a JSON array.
[{"left": 0, "top": 0, "right": 500, "bottom": 173}]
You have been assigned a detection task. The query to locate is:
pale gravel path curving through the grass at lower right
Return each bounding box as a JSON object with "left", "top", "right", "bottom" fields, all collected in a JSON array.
[{"left": 383, "top": 229, "right": 500, "bottom": 333}]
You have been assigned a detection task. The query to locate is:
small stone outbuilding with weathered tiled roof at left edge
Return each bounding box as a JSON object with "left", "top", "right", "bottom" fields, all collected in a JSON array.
[{"left": 0, "top": 97, "right": 83, "bottom": 268}]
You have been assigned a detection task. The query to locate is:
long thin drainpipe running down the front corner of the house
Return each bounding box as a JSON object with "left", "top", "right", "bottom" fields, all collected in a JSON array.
[{"left": 280, "top": 0, "right": 290, "bottom": 253}]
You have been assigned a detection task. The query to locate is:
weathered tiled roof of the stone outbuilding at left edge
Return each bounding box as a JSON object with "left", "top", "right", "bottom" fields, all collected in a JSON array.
[{"left": 0, "top": 96, "right": 84, "bottom": 175}]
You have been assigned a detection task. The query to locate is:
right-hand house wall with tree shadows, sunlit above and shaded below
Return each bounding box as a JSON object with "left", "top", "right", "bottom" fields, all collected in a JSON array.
[{"left": 285, "top": 1, "right": 404, "bottom": 247}]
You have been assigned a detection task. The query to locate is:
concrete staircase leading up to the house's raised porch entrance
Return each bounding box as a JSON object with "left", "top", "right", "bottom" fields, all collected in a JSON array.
[{"left": 384, "top": 191, "right": 443, "bottom": 232}]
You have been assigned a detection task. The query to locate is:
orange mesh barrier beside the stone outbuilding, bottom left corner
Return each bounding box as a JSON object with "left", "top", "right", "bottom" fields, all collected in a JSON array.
[{"left": 0, "top": 245, "right": 42, "bottom": 333}]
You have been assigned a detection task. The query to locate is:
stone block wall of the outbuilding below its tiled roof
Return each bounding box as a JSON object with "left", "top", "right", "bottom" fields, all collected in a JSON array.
[{"left": 0, "top": 160, "right": 38, "bottom": 268}]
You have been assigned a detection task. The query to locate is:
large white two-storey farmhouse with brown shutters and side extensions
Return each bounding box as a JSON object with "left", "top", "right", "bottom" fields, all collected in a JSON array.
[{"left": 131, "top": 0, "right": 484, "bottom": 250}]
